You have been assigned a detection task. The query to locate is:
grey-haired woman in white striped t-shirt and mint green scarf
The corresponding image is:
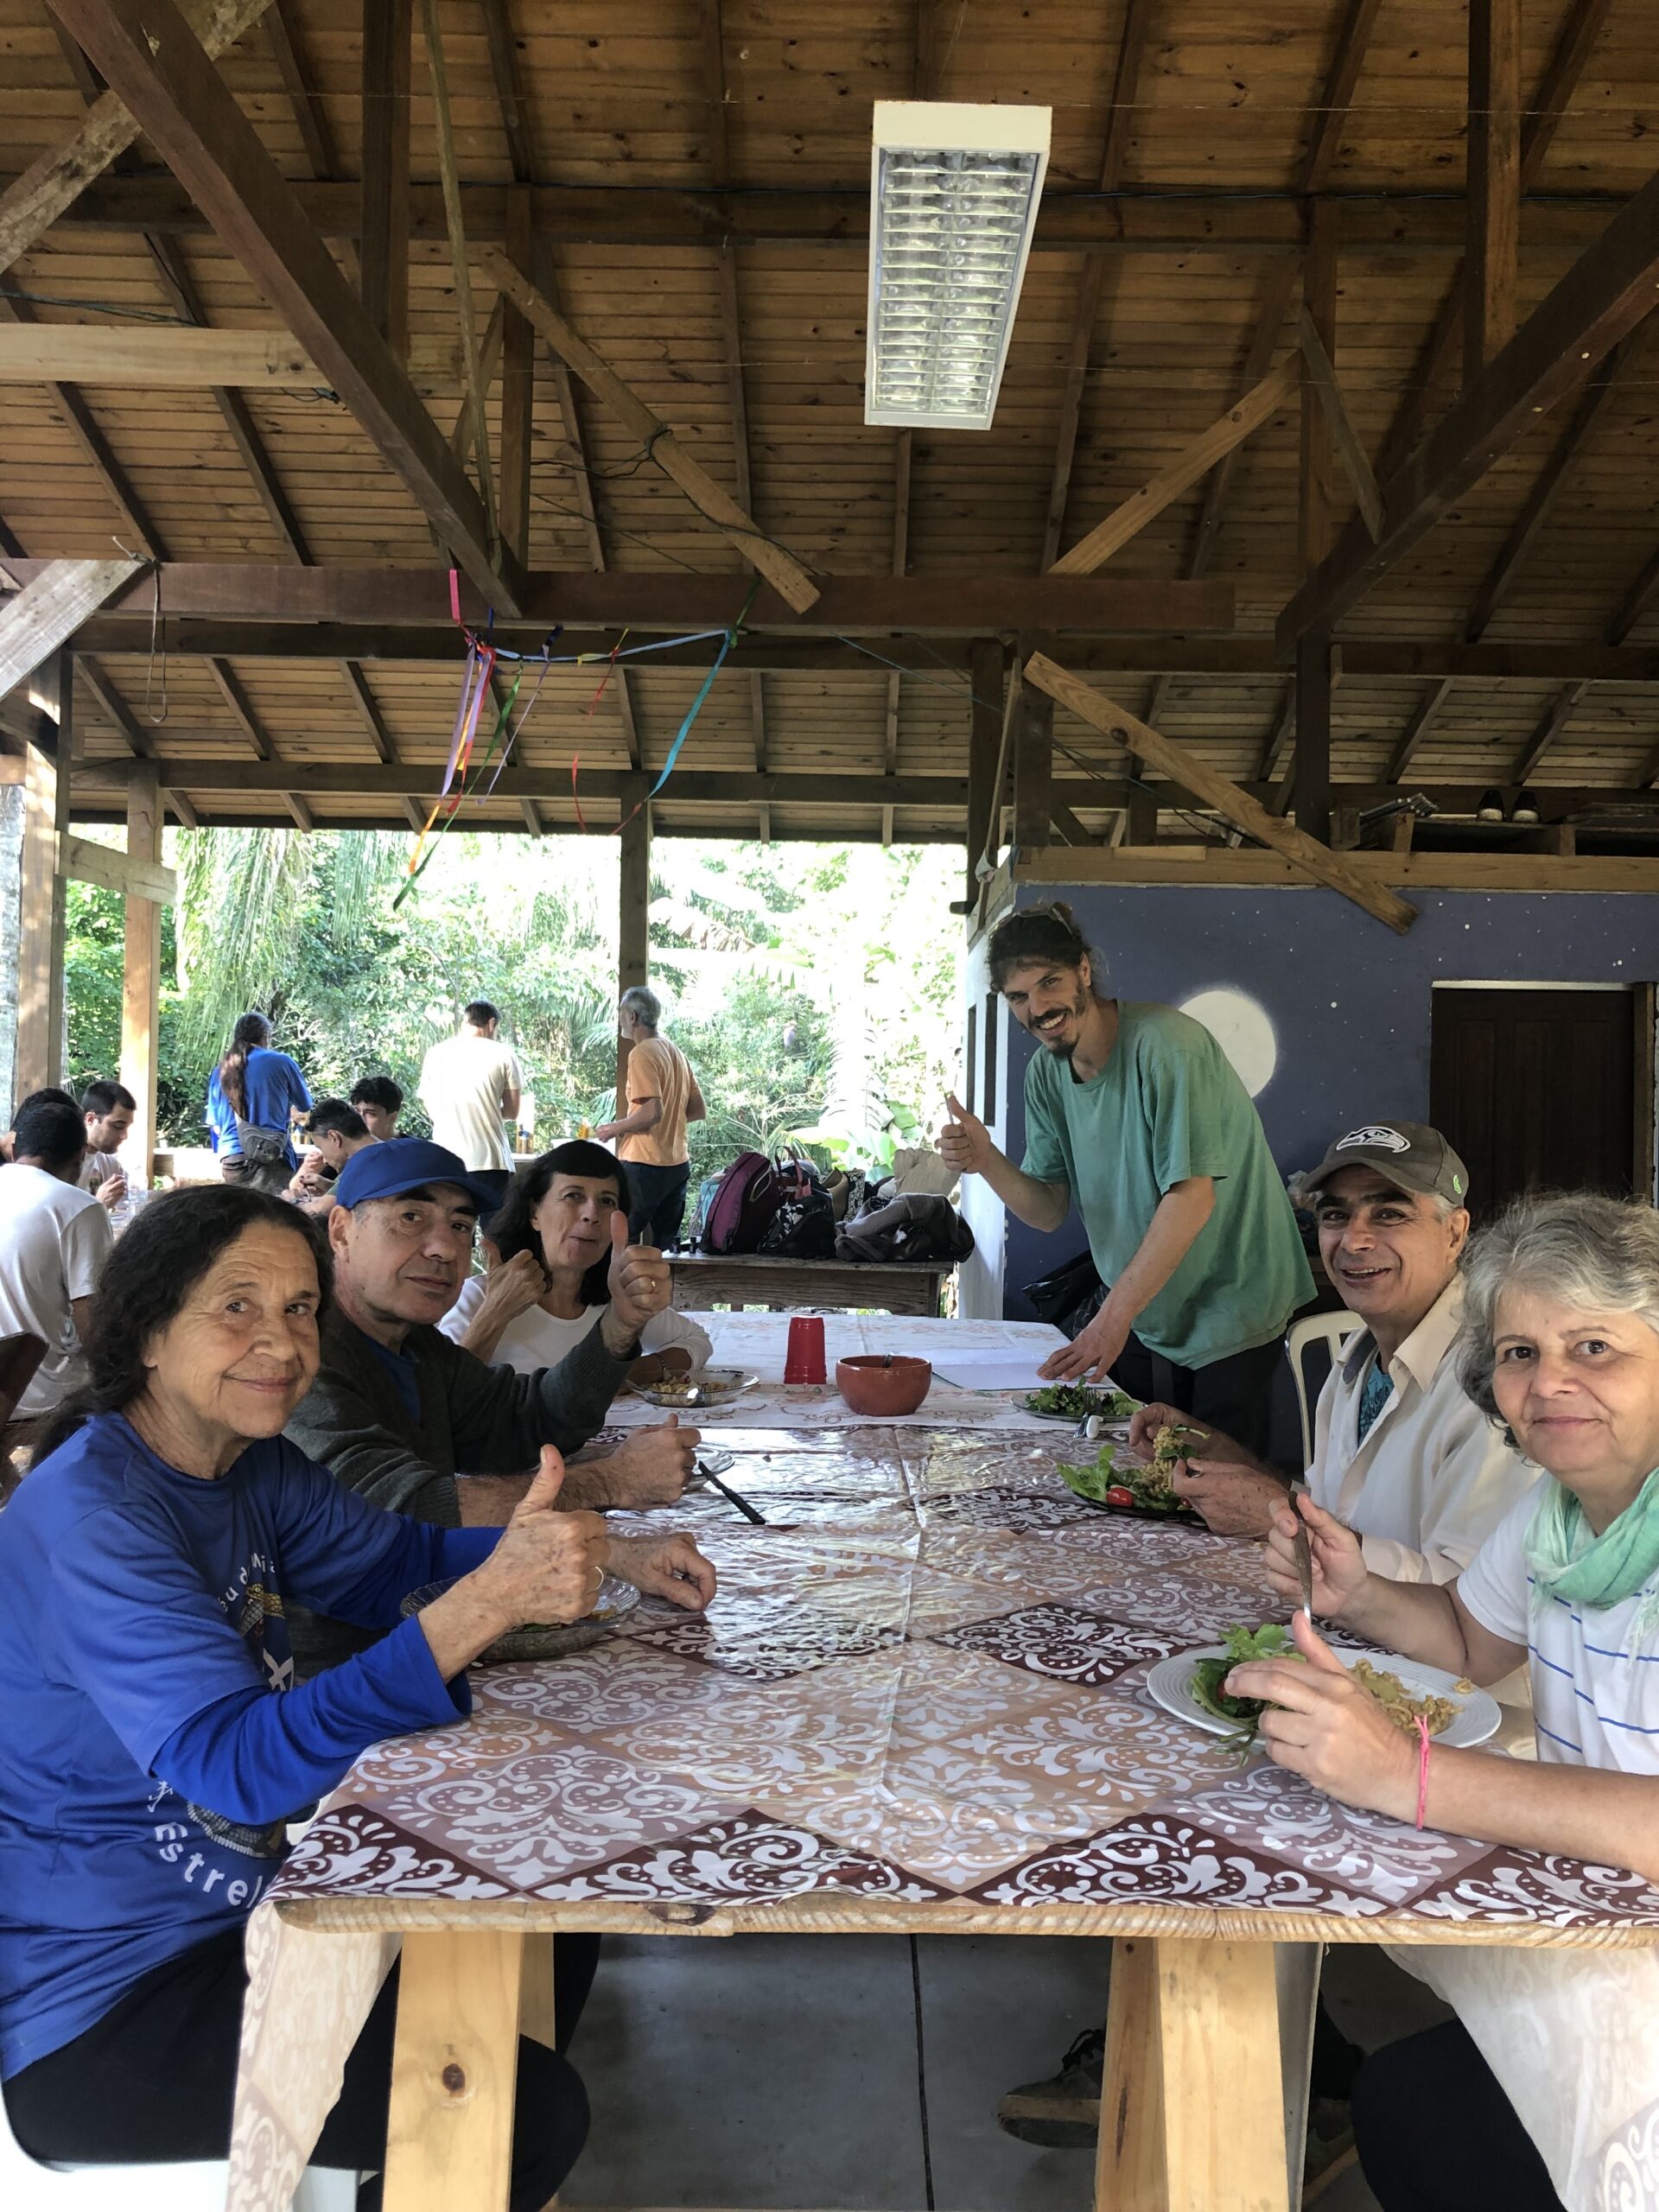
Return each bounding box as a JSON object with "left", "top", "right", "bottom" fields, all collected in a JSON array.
[{"left": 1225, "top": 1192, "right": 1659, "bottom": 2212}]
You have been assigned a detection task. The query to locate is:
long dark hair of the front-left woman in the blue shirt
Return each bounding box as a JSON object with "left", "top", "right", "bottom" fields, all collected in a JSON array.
[{"left": 35, "top": 1184, "right": 334, "bottom": 1469}]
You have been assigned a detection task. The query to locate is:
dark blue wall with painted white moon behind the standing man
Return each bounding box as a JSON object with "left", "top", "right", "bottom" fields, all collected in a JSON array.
[{"left": 1002, "top": 885, "right": 1659, "bottom": 1319}]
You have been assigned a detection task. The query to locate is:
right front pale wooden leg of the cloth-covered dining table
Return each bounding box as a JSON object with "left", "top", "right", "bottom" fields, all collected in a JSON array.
[{"left": 1095, "top": 1940, "right": 1289, "bottom": 2212}]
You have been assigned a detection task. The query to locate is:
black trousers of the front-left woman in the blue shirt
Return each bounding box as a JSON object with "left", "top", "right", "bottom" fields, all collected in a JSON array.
[{"left": 4, "top": 1929, "right": 600, "bottom": 2212}]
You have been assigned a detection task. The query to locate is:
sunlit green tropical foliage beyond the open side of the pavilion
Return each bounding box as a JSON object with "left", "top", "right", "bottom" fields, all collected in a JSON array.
[{"left": 68, "top": 830, "right": 960, "bottom": 1177}]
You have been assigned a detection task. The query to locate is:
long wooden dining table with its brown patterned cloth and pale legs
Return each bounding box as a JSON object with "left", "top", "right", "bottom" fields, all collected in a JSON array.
[{"left": 230, "top": 1425, "right": 1659, "bottom": 2212}]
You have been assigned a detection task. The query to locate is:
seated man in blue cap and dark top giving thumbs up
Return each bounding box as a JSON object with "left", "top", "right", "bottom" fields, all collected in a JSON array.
[{"left": 288, "top": 1137, "right": 715, "bottom": 1670}]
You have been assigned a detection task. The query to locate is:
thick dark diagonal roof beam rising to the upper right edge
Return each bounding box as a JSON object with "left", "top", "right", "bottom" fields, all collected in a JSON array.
[{"left": 1276, "top": 161, "right": 1659, "bottom": 655}]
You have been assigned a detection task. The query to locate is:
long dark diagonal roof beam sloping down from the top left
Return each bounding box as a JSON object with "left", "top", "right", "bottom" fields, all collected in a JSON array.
[{"left": 53, "top": 0, "right": 522, "bottom": 613}]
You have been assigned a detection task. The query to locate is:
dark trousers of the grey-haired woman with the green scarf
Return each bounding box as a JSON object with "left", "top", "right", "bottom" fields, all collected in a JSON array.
[{"left": 1354, "top": 2019, "right": 1564, "bottom": 2212}]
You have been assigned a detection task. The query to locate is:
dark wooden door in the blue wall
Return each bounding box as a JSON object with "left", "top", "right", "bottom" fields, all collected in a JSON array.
[{"left": 1429, "top": 988, "right": 1652, "bottom": 1219}]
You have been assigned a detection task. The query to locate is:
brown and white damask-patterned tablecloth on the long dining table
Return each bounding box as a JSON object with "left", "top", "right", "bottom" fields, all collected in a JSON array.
[{"left": 232, "top": 1427, "right": 1659, "bottom": 2212}]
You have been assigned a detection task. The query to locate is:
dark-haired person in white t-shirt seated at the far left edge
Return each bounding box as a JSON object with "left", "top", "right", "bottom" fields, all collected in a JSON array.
[{"left": 0, "top": 1099, "right": 115, "bottom": 1421}]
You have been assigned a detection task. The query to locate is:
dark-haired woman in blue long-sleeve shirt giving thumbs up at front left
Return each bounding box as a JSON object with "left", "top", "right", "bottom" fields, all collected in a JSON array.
[{"left": 0, "top": 1188, "right": 604, "bottom": 2212}]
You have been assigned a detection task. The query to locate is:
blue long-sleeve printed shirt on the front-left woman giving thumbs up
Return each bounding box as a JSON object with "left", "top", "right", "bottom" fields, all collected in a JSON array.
[{"left": 0, "top": 1414, "right": 500, "bottom": 2077}]
